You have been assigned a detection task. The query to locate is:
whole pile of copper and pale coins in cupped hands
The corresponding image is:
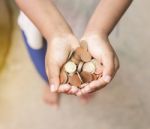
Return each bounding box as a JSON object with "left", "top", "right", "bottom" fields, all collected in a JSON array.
[{"left": 60, "top": 41, "right": 103, "bottom": 88}]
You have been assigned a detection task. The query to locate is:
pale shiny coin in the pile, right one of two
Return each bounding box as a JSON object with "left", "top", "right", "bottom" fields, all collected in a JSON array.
[{"left": 83, "top": 62, "right": 95, "bottom": 74}]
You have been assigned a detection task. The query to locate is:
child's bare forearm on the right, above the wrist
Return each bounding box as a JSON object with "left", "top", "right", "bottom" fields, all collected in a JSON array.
[{"left": 85, "top": 0, "right": 132, "bottom": 36}]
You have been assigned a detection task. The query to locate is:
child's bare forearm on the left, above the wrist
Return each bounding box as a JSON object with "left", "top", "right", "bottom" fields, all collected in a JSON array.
[{"left": 16, "top": 0, "right": 71, "bottom": 39}]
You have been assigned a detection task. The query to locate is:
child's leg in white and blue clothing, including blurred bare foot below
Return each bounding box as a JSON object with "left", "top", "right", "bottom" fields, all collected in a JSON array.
[{"left": 18, "top": 13, "right": 59, "bottom": 105}]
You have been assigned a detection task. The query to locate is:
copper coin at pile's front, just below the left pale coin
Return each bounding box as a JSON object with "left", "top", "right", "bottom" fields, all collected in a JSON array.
[{"left": 68, "top": 74, "right": 81, "bottom": 87}]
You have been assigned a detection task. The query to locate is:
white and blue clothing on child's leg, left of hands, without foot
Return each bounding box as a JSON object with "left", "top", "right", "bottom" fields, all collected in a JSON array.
[{"left": 18, "top": 12, "right": 48, "bottom": 81}]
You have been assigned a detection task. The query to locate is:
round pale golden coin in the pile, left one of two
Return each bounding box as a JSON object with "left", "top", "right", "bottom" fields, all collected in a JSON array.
[{"left": 64, "top": 61, "right": 76, "bottom": 73}]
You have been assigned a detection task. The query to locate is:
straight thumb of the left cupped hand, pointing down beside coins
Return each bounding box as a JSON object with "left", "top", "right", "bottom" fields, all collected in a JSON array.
[{"left": 47, "top": 63, "right": 59, "bottom": 92}]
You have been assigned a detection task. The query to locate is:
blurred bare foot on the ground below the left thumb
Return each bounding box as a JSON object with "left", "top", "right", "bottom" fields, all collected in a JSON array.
[{"left": 43, "top": 86, "right": 60, "bottom": 107}]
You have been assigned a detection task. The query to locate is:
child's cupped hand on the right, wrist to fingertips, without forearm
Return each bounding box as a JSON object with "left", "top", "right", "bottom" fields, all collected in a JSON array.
[{"left": 77, "top": 34, "right": 119, "bottom": 96}]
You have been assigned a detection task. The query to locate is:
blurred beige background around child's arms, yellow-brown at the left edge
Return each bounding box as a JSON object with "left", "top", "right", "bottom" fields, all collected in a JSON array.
[{"left": 0, "top": 0, "right": 150, "bottom": 129}]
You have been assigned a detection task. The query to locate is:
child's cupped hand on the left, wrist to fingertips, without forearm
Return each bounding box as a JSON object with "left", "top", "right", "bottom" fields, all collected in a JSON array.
[{"left": 46, "top": 34, "right": 79, "bottom": 94}]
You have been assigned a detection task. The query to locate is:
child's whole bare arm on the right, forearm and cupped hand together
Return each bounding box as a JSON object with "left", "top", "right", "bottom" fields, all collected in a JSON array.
[{"left": 77, "top": 0, "right": 132, "bottom": 96}]
